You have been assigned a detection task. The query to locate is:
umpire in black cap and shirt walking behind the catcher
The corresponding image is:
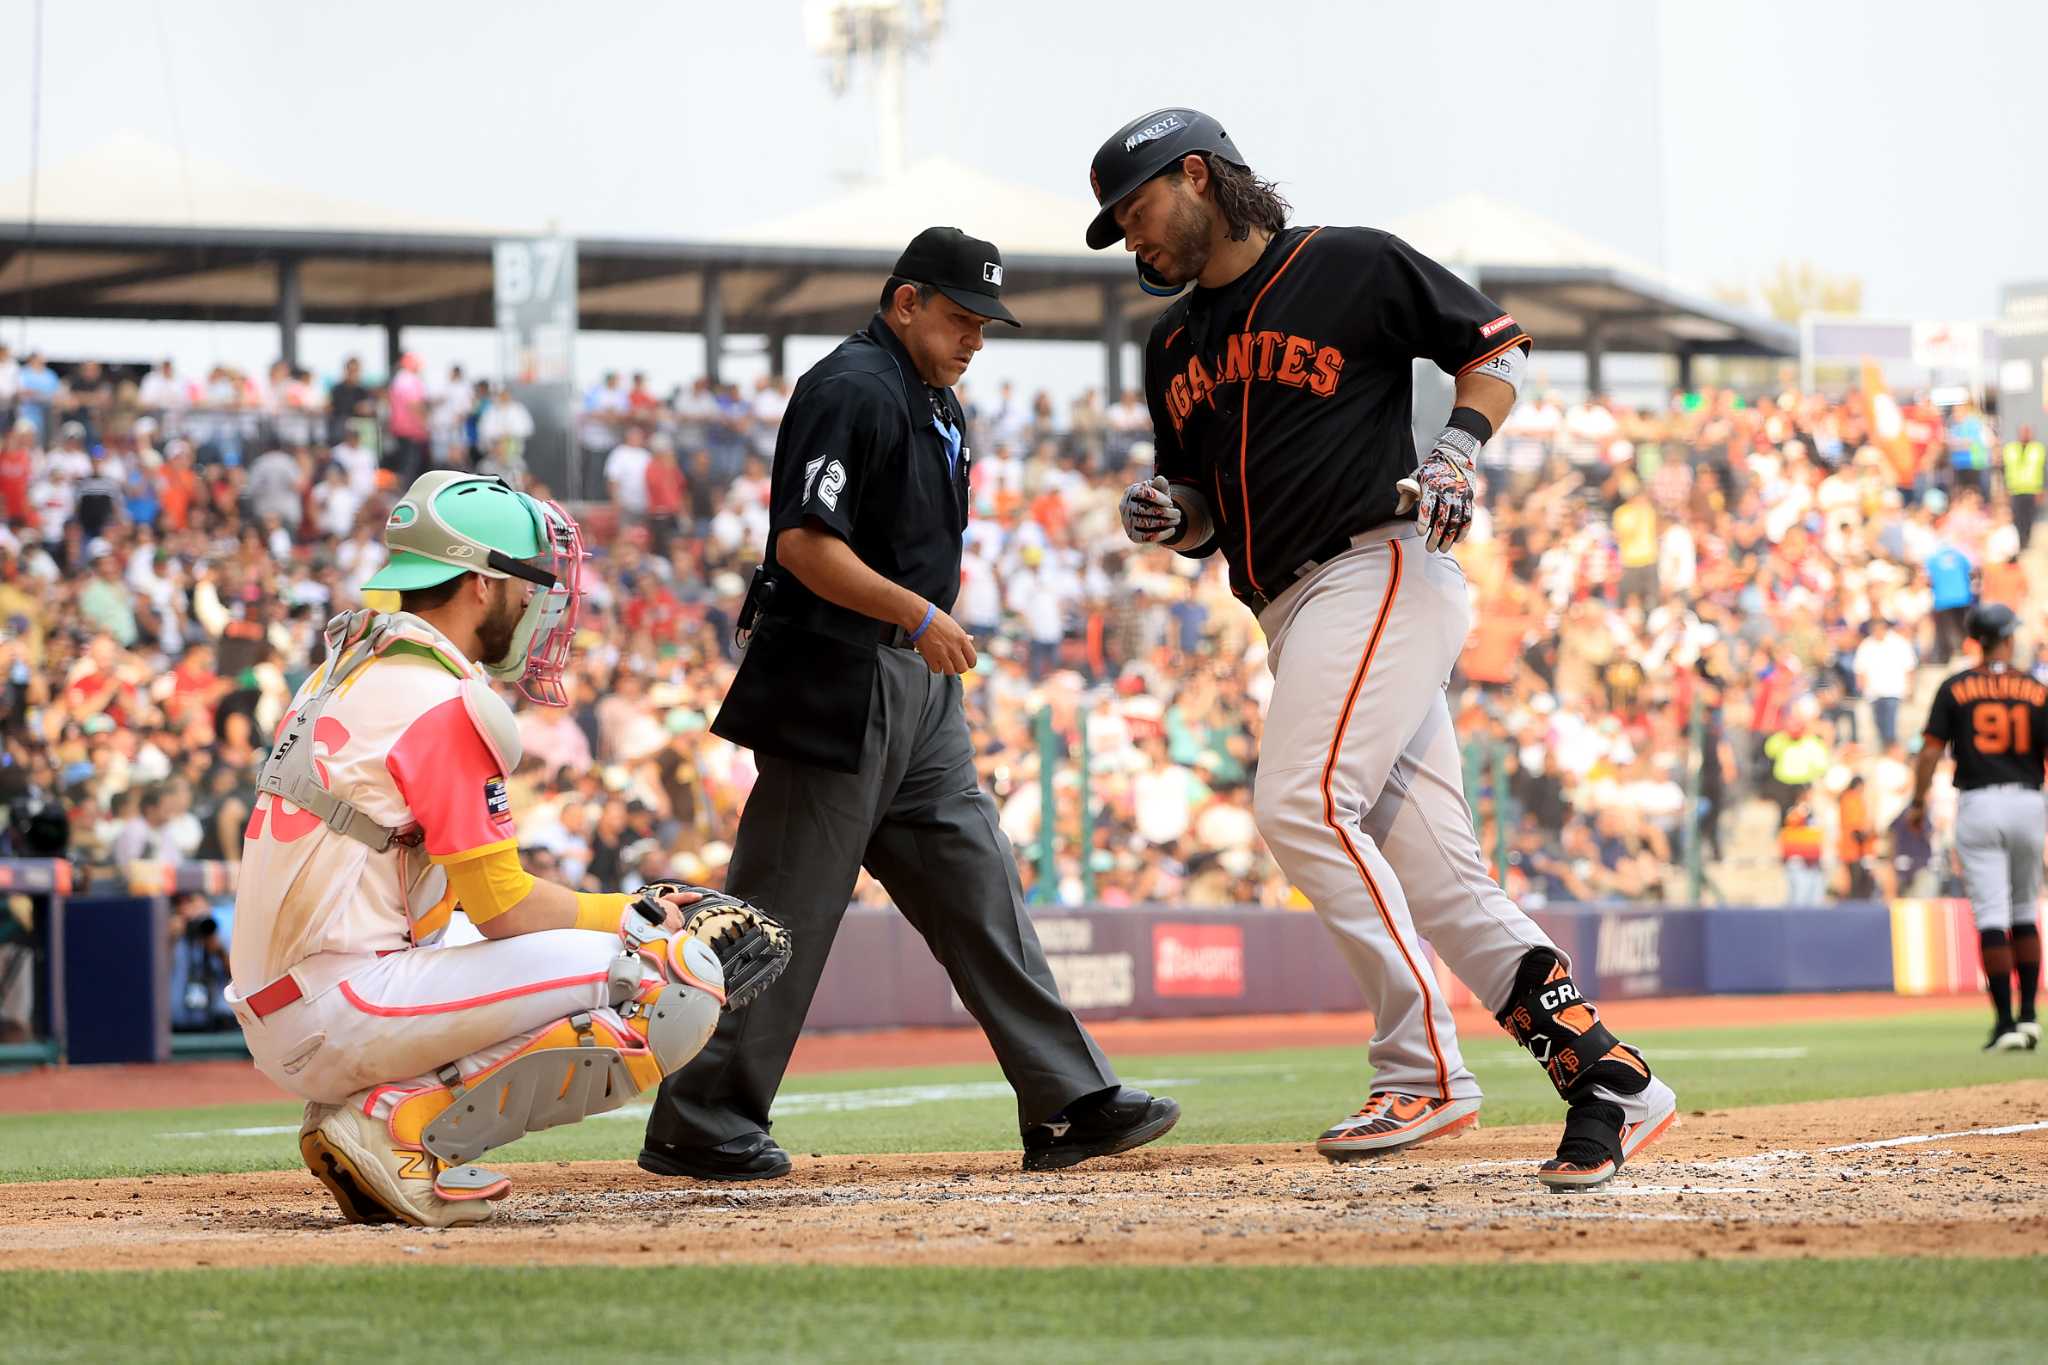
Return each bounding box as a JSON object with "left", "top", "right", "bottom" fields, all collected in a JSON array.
[{"left": 639, "top": 227, "right": 1180, "bottom": 1181}]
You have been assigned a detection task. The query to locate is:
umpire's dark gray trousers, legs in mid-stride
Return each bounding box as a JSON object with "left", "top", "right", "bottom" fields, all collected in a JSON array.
[{"left": 647, "top": 647, "right": 1116, "bottom": 1146}]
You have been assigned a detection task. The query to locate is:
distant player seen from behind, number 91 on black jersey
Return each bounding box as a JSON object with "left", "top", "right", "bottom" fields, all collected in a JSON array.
[{"left": 1907, "top": 604, "right": 2048, "bottom": 1052}]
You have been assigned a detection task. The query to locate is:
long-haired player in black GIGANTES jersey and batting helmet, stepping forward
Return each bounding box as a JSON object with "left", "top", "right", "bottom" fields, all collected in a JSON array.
[{"left": 1087, "top": 108, "right": 1677, "bottom": 1189}]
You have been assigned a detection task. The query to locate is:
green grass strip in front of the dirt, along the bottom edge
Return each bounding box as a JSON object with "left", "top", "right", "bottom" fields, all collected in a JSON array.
[{"left": 0, "top": 1261, "right": 2048, "bottom": 1365}]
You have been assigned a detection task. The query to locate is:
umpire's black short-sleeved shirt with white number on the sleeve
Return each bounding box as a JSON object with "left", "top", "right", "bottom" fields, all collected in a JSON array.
[{"left": 768, "top": 313, "right": 969, "bottom": 612}]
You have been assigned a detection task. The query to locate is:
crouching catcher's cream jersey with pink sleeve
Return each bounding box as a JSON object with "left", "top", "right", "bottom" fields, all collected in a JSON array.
[{"left": 229, "top": 622, "right": 514, "bottom": 997}]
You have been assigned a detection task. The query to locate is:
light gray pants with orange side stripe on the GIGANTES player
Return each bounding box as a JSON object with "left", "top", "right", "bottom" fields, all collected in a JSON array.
[{"left": 1253, "top": 524, "right": 1569, "bottom": 1099}]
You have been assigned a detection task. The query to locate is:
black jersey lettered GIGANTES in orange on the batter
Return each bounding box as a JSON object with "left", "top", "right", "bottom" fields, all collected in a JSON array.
[{"left": 1145, "top": 227, "right": 1530, "bottom": 606}]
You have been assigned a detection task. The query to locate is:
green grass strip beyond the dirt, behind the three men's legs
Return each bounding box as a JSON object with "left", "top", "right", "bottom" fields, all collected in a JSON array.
[{"left": 0, "top": 1007, "right": 2015, "bottom": 1183}]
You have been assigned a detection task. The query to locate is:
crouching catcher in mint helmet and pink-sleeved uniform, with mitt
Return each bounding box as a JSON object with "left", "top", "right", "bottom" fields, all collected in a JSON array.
[{"left": 227, "top": 471, "right": 788, "bottom": 1228}]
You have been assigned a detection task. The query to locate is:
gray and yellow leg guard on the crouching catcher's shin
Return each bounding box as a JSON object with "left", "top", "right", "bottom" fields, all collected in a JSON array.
[{"left": 391, "top": 957, "right": 723, "bottom": 1166}]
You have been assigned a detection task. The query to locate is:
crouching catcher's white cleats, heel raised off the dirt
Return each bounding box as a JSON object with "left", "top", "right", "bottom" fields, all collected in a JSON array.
[{"left": 299, "top": 1103, "right": 512, "bottom": 1228}]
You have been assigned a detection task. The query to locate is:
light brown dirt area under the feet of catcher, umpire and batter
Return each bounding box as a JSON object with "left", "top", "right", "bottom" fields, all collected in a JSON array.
[{"left": 0, "top": 1081, "right": 2048, "bottom": 1269}]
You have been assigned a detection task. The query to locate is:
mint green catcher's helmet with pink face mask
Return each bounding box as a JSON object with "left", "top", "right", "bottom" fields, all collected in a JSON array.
[{"left": 362, "top": 469, "right": 584, "bottom": 706}]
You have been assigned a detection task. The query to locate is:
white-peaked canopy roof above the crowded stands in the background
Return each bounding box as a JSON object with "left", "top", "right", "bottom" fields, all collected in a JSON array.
[{"left": 0, "top": 137, "right": 1798, "bottom": 389}]
